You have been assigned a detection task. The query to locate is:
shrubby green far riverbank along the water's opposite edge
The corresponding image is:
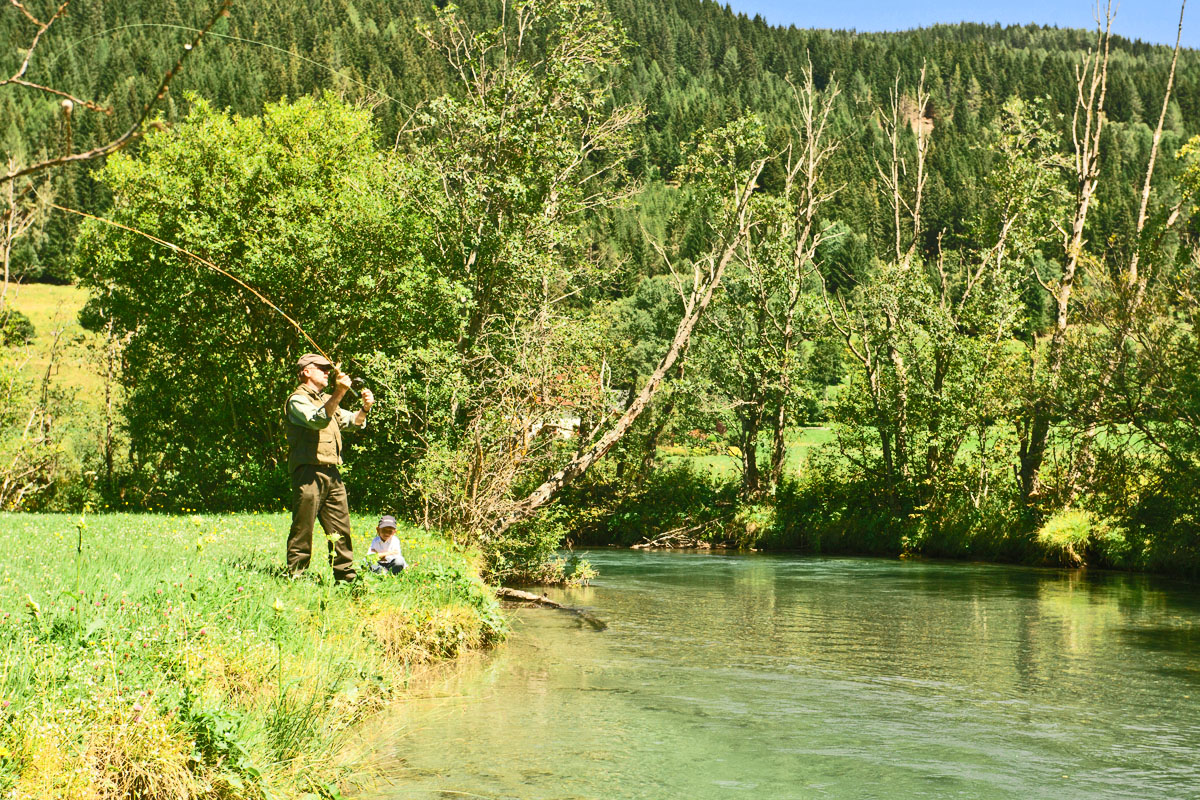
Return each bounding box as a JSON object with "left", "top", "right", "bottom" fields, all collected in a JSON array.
[{"left": 559, "top": 464, "right": 1200, "bottom": 578}]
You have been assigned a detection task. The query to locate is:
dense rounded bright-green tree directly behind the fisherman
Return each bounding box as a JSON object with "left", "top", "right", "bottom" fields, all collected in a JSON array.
[{"left": 78, "top": 97, "right": 436, "bottom": 507}]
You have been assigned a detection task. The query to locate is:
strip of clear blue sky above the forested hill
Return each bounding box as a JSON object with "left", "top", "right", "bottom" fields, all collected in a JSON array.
[{"left": 722, "top": 0, "right": 1200, "bottom": 48}]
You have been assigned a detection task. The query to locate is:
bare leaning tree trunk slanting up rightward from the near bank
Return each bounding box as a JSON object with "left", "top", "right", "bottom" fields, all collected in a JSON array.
[{"left": 491, "top": 160, "right": 767, "bottom": 536}]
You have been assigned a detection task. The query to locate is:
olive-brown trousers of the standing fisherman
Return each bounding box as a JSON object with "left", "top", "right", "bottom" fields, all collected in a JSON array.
[{"left": 288, "top": 464, "right": 355, "bottom": 581}]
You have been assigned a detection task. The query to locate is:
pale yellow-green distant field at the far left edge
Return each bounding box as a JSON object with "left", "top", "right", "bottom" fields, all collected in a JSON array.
[{"left": 6, "top": 283, "right": 103, "bottom": 407}]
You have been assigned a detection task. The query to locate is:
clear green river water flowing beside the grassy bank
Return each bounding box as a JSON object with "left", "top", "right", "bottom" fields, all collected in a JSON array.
[{"left": 388, "top": 551, "right": 1200, "bottom": 800}]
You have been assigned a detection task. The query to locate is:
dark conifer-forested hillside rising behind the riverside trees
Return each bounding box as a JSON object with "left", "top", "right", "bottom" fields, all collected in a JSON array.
[{"left": 0, "top": 0, "right": 1200, "bottom": 281}]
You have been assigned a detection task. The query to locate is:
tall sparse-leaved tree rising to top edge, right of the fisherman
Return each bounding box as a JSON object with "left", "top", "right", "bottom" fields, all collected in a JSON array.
[{"left": 377, "top": 0, "right": 641, "bottom": 561}]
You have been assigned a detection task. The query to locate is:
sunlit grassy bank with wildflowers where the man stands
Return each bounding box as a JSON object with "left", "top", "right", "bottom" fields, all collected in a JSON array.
[{"left": 0, "top": 515, "right": 503, "bottom": 800}]
